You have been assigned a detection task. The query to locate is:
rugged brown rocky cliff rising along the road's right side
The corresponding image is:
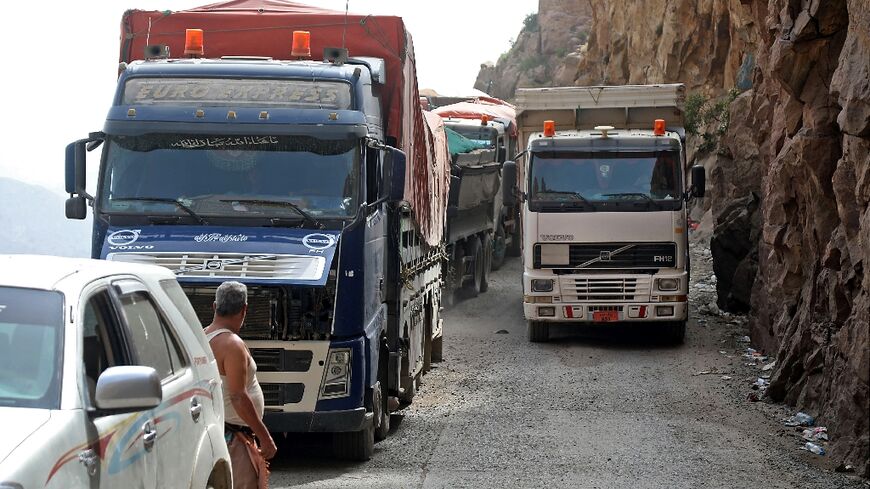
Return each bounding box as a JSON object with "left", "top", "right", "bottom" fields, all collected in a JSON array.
[{"left": 478, "top": 0, "right": 870, "bottom": 477}]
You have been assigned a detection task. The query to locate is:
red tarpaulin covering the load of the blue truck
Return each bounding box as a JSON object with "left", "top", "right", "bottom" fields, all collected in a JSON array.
[{"left": 120, "top": 0, "right": 449, "bottom": 245}]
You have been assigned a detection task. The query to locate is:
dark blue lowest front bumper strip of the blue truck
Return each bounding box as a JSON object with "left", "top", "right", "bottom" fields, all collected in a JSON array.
[{"left": 263, "top": 407, "right": 374, "bottom": 433}]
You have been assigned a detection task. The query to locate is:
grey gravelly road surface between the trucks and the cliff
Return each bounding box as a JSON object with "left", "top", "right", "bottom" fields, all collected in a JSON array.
[{"left": 272, "top": 254, "right": 867, "bottom": 489}]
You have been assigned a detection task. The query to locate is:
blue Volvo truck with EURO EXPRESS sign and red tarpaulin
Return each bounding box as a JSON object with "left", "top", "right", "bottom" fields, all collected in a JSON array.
[{"left": 66, "top": 0, "right": 449, "bottom": 460}]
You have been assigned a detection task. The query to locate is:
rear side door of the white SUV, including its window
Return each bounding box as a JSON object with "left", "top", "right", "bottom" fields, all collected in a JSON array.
[{"left": 113, "top": 280, "right": 200, "bottom": 487}]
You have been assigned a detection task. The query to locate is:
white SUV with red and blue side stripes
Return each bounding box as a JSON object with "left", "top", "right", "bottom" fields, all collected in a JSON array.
[{"left": 0, "top": 255, "right": 232, "bottom": 489}]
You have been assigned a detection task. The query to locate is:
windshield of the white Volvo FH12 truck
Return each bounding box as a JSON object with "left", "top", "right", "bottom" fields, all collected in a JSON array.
[{"left": 529, "top": 151, "right": 682, "bottom": 204}]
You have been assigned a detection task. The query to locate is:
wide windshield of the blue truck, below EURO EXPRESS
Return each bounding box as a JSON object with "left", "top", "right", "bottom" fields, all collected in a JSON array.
[{"left": 100, "top": 134, "right": 361, "bottom": 218}]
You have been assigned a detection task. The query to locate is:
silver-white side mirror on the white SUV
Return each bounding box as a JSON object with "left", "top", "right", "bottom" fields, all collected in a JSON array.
[{"left": 94, "top": 365, "right": 163, "bottom": 415}]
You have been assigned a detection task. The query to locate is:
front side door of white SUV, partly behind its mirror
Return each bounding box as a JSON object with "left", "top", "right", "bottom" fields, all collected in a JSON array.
[{"left": 75, "top": 283, "right": 157, "bottom": 489}]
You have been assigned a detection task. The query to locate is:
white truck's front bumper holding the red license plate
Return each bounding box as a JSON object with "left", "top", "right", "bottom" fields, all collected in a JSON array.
[{"left": 523, "top": 302, "right": 689, "bottom": 324}]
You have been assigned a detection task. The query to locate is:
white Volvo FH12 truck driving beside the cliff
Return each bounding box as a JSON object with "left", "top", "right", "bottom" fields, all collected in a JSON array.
[{"left": 505, "top": 84, "right": 705, "bottom": 342}]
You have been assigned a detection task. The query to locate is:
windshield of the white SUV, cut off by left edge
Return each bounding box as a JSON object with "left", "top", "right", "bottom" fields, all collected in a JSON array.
[{"left": 0, "top": 287, "right": 63, "bottom": 409}]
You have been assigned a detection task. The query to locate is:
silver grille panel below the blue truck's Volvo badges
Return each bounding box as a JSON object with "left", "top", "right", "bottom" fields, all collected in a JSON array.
[{"left": 106, "top": 253, "right": 326, "bottom": 280}]
